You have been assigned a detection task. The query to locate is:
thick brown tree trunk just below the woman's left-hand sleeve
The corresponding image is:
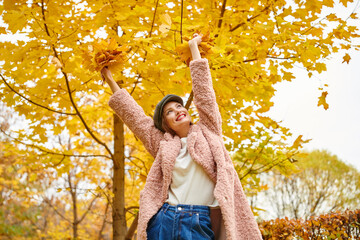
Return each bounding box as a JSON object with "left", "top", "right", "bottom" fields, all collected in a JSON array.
[{"left": 112, "top": 114, "right": 126, "bottom": 240}]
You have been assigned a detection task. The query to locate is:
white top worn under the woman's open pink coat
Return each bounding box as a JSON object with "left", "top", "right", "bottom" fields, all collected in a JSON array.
[{"left": 166, "top": 137, "right": 219, "bottom": 207}]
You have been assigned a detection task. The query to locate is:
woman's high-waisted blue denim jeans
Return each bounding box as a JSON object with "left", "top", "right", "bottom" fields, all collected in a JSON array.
[{"left": 146, "top": 203, "right": 214, "bottom": 240}]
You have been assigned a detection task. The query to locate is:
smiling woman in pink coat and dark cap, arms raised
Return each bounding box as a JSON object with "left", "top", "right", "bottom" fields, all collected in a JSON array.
[{"left": 101, "top": 35, "right": 261, "bottom": 240}]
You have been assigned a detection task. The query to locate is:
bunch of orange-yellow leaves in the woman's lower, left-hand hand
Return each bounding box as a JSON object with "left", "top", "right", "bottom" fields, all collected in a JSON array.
[{"left": 83, "top": 39, "right": 128, "bottom": 71}]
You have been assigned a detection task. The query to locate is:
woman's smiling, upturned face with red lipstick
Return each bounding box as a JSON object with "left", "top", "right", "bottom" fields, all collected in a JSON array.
[{"left": 163, "top": 102, "right": 191, "bottom": 133}]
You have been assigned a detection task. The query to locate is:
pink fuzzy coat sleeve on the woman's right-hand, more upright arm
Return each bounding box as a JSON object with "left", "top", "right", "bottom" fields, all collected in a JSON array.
[{"left": 190, "top": 58, "right": 222, "bottom": 136}]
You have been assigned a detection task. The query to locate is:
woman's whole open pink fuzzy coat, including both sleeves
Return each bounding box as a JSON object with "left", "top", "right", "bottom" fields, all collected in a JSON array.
[{"left": 109, "top": 59, "right": 262, "bottom": 240}]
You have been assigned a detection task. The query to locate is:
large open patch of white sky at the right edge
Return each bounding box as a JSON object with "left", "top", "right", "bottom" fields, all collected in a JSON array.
[{"left": 269, "top": 42, "right": 360, "bottom": 171}]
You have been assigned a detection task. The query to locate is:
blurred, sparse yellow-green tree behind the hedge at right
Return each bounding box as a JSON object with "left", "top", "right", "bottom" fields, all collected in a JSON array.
[{"left": 256, "top": 150, "right": 360, "bottom": 219}]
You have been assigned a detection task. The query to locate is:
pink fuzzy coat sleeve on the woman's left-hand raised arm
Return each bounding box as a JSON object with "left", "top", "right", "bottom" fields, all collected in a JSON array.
[{"left": 109, "top": 89, "right": 164, "bottom": 158}]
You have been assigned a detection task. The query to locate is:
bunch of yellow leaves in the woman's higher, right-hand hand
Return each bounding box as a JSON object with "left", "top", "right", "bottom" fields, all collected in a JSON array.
[{"left": 175, "top": 32, "right": 214, "bottom": 66}]
